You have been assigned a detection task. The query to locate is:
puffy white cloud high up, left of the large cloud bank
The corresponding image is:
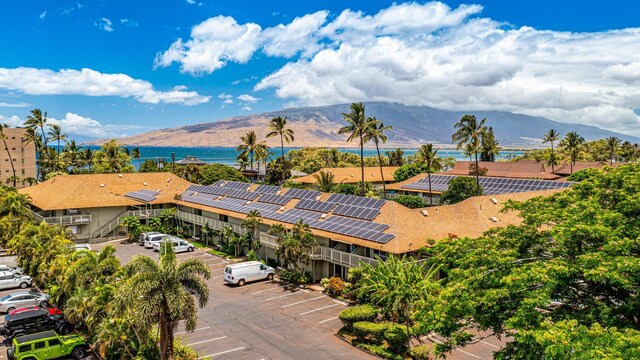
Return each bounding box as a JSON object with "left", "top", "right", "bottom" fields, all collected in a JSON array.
[{"left": 154, "top": 16, "right": 262, "bottom": 75}]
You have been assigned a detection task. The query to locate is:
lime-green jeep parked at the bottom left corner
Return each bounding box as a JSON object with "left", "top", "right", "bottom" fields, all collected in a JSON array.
[{"left": 7, "top": 331, "right": 89, "bottom": 360}]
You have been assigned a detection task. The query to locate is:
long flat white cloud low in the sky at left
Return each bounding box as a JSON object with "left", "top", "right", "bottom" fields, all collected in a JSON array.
[{"left": 0, "top": 67, "right": 211, "bottom": 105}]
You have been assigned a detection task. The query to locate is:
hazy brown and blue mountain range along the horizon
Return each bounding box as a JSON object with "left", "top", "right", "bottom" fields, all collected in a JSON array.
[{"left": 87, "top": 102, "right": 640, "bottom": 148}]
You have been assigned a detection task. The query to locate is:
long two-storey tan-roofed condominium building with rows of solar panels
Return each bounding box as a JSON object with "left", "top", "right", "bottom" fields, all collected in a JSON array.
[{"left": 20, "top": 173, "right": 560, "bottom": 280}]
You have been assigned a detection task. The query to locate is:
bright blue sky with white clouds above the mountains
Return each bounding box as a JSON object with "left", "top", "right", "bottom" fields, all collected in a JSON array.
[{"left": 0, "top": 0, "right": 640, "bottom": 138}]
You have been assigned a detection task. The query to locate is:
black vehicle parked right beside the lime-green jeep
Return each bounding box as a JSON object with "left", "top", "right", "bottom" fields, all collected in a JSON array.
[{"left": 0, "top": 310, "right": 73, "bottom": 340}]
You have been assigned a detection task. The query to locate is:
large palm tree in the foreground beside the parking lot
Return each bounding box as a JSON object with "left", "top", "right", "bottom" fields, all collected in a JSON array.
[{"left": 115, "top": 241, "right": 211, "bottom": 360}]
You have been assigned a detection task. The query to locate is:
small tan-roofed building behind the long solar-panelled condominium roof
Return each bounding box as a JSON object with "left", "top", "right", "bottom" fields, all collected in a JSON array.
[{"left": 293, "top": 166, "right": 398, "bottom": 187}]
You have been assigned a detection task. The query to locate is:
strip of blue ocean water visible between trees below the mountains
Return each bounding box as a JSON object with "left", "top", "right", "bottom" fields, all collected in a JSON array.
[{"left": 85, "top": 146, "right": 524, "bottom": 167}]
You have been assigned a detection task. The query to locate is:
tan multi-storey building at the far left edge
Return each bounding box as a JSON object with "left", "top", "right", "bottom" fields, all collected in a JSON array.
[{"left": 0, "top": 128, "right": 36, "bottom": 188}]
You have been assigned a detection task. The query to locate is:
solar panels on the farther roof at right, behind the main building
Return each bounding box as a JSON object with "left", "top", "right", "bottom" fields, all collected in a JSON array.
[{"left": 402, "top": 175, "right": 573, "bottom": 195}]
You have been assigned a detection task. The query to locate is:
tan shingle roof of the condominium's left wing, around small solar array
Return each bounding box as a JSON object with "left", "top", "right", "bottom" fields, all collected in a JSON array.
[{"left": 19, "top": 172, "right": 191, "bottom": 210}]
